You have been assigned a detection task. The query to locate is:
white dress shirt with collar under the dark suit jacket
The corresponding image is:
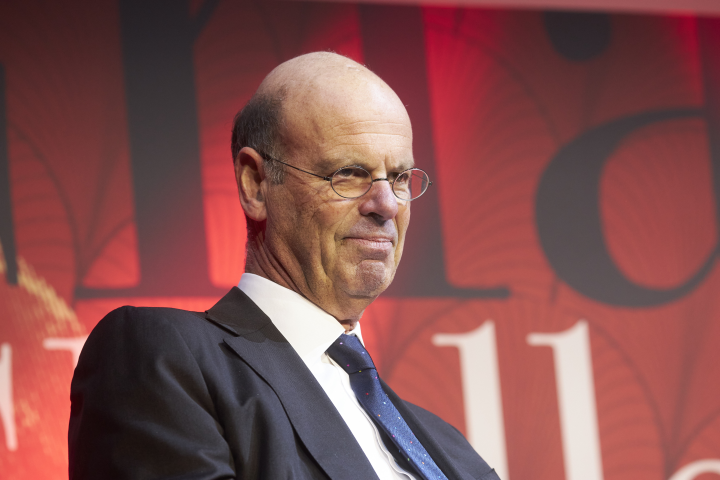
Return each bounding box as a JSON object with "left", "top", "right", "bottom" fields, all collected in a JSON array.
[{"left": 238, "top": 273, "right": 415, "bottom": 480}]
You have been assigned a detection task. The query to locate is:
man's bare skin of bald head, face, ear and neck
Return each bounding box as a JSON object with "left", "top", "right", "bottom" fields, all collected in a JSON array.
[{"left": 235, "top": 53, "right": 413, "bottom": 330}]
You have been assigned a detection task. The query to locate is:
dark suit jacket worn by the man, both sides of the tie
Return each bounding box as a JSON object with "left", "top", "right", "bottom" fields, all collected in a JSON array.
[{"left": 68, "top": 288, "right": 498, "bottom": 480}]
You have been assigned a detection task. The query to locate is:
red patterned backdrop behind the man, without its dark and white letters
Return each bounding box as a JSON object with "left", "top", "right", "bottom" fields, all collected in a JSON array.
[{"left": 0, "top": 0, "right": 720, "bottom": 480}]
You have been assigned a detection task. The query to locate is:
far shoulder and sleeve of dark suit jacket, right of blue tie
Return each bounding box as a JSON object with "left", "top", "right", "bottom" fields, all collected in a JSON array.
[{"left": 405, "top": 402, "right": 500, "bottom": 480}]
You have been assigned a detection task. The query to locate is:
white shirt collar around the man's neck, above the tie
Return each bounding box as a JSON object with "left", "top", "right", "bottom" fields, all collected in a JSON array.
[{"left": 238, "top": 273, "right": 362, "bottom": 366}]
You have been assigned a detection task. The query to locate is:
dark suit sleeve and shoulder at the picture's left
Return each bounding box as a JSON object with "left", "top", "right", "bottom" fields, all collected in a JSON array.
[{"left": 68, "top": 307, "right": 235, "bottom": 480}]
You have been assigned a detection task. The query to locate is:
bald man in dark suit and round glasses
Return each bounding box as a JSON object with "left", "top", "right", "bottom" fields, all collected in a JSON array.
[{"left": 69, "top": 53, "right": 498, "bottom": 480}]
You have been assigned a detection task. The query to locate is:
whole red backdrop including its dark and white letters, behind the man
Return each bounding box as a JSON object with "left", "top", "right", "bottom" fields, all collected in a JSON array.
[{"left": 0, "top": 0, "right": 720, "bottom": 480}]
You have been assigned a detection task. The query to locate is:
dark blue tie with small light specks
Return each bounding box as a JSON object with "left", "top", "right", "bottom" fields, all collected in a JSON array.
[{"left": 327, "top": 334, "right": 447, "bottom": 480}]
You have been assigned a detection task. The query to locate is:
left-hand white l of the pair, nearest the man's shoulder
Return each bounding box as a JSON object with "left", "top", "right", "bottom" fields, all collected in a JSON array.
[{"left": 432, "top": 320, "right": 510, "bottom": 480}]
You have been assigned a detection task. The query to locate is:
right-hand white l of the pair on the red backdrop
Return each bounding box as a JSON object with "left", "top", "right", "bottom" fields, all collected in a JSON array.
[{"left": 527, "top": 320, "right": 603, "bottom": 480}]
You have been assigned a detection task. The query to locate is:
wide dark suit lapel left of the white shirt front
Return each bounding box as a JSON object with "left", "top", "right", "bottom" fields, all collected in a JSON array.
[{"left": 206, "top": 287, "right": 378, "bottom": 479}]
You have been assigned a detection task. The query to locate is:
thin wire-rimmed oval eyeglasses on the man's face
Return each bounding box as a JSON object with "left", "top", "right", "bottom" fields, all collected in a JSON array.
[{"left": 263, "top": 155, "right": 432, "bottom": 200}]
